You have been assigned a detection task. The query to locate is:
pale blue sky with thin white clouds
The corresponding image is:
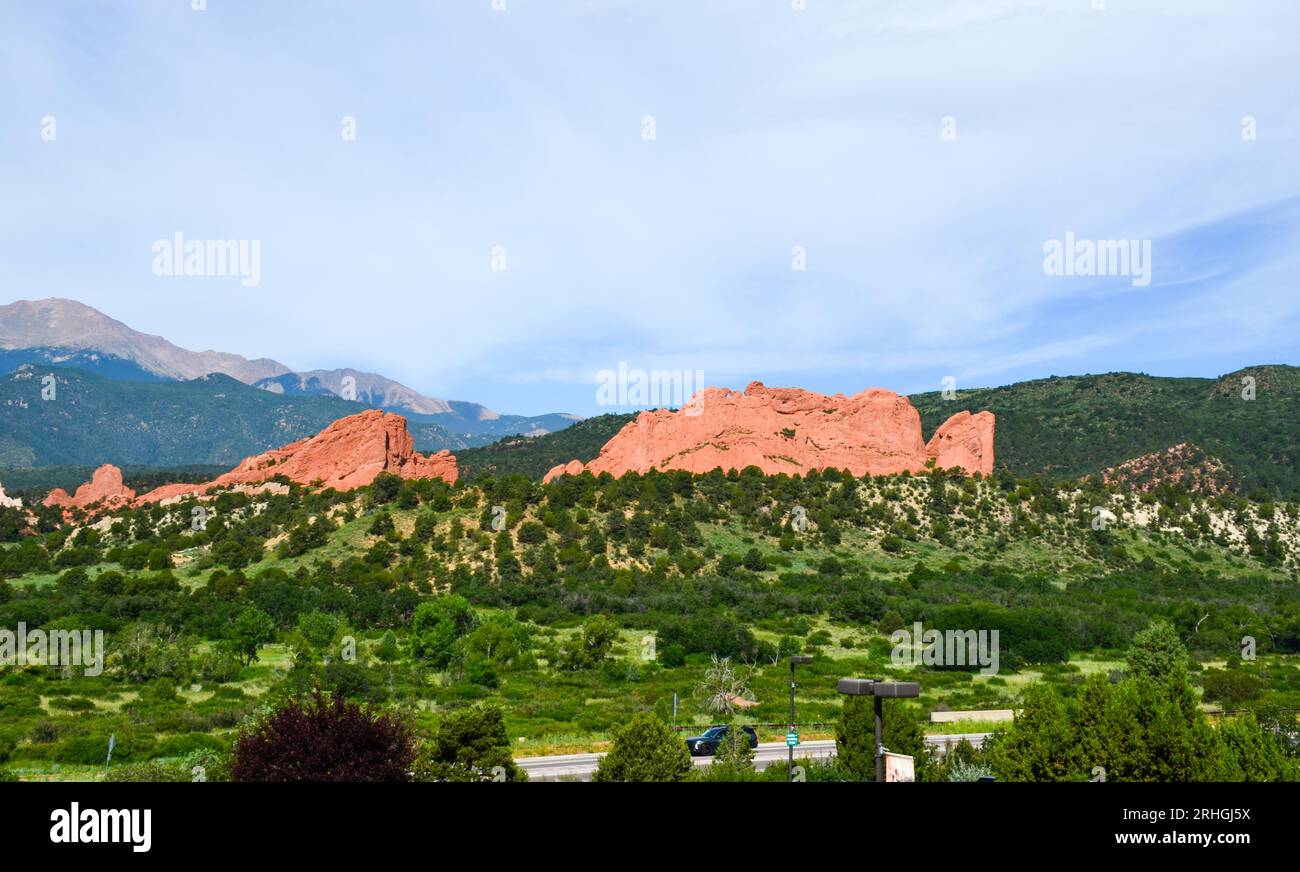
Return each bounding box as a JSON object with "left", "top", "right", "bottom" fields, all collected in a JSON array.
[{"left": 0, "top": 0, "right": 1300, "bottom": 415}]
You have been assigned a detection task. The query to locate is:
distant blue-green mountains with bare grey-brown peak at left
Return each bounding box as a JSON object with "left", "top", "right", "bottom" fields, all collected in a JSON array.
[{"left": 0, "top": 299, "right": 580, "bottom": 465}]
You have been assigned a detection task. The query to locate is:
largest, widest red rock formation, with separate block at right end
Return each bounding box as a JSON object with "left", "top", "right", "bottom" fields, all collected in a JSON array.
[{"left": 545, "top": 382, "right": 993, "bottom": 481}]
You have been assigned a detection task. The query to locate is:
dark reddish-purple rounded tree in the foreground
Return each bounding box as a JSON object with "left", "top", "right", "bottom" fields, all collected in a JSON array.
[{"left": 230, "top": 687, "right": 415, "bottom": 781}]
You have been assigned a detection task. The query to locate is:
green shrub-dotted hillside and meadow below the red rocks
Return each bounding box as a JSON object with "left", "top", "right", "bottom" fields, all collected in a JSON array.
[{"left": 0, "top": 472, "right": 1300, "bottom": 777}]
